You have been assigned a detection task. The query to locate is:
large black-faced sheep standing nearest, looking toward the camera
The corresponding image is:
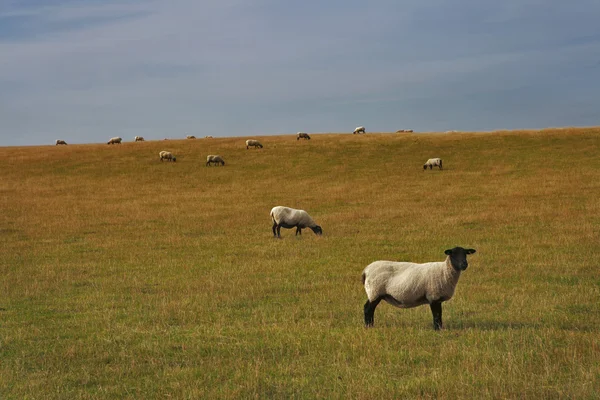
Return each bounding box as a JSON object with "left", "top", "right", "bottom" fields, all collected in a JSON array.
[{"left": 362, "top": 247, "right": 475, "bottom": 330}]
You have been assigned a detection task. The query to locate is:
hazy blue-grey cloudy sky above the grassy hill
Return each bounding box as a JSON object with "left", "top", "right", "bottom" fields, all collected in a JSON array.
[{"left": 0, "top": 0, "right": 600, "bottom": 146}]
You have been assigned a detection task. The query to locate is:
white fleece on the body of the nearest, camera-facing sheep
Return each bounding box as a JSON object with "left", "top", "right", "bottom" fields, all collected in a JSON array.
[{"left": 363, "top": 257, "right": 461, "bottom": 308}]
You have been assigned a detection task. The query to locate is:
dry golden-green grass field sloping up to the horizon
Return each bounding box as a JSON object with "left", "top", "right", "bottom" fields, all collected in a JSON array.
[{"left": 0, "top": 128, "right": 600, "bottom": 399}]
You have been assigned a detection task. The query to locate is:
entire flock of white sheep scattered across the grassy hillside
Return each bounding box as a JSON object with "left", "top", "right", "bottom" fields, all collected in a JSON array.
[{"left": 56, "top": 126, "right": 468, "bottom": 330}]
